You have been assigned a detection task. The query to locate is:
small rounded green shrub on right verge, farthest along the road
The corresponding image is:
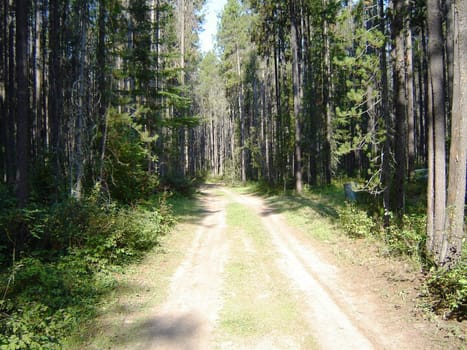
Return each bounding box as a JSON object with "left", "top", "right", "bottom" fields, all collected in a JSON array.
[{"left": 338, "top": 204, "right": 375, "bottom": 238}]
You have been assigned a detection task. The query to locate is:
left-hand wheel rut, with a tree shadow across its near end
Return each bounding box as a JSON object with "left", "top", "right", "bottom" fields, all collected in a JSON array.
[{"left": 141, "top": 189, "right": 229, "bottom": 350}]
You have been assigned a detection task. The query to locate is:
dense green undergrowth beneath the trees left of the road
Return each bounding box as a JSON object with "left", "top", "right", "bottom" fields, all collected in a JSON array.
[{"left": 0, "top": 190, "right": 174, "bottom": 349}]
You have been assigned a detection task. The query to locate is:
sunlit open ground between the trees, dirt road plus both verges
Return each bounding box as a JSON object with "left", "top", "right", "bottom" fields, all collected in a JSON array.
[{"left": 71, "top": 185, "right": 467, "bottom": 350}]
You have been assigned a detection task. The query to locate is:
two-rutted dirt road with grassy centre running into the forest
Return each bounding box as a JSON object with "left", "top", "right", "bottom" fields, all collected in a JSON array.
[{"left": 105, "top": 185, "right": 460, "bottom": 350}]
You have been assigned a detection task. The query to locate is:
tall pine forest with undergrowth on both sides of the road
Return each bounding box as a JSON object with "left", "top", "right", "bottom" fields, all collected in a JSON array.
[{"left": 0, "top": 0, "right": 467, "bottom": 349}]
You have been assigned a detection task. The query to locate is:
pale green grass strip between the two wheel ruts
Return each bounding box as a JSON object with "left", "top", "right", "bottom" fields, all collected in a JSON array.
[{"left": 218, "top": 203, "right": 316, "bottom": 349}]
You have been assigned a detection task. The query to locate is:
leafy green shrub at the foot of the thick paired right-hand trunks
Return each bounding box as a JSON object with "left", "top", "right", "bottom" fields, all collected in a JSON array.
[{"left": 426, "top": 258, "right": 467, "bottom": 320}]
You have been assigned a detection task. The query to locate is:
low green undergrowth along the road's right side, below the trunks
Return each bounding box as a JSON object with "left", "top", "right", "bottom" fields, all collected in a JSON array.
[{"left": 339, "top": 196, "right": 467, "bottom": 320}]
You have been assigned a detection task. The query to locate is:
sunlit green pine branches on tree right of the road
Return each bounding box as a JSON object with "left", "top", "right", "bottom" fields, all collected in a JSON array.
[{"left": 333, "top": 1, "right": 387, "bottom": 182}]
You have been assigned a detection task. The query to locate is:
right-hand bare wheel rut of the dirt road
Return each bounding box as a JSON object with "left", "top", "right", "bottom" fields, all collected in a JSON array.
[{"left": 225, "top": 190, "right": 384, "bottom": 350}]
